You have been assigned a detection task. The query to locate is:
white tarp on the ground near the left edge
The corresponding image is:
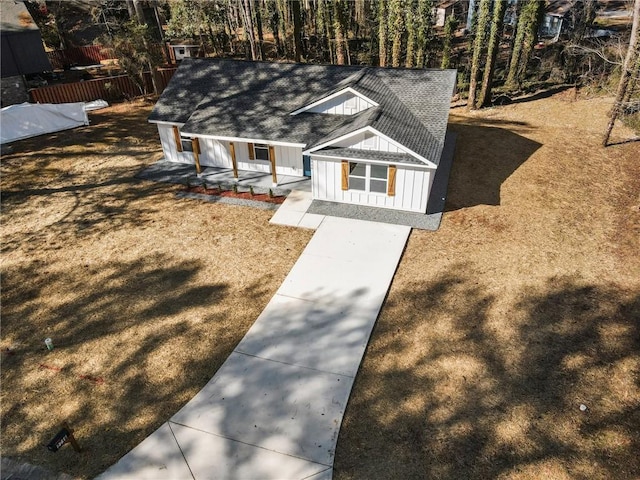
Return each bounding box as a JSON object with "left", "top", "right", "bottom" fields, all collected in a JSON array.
[{"left": 0, "top": 102, "right": 89, "bottom": 143}]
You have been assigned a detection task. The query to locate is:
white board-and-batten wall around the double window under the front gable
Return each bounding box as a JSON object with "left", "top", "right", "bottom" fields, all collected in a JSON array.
[{"left": 311, "top": 154, "right": 435, "bottom": 213}]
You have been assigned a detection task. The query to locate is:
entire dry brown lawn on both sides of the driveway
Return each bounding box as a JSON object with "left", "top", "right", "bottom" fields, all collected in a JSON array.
[{"left": 0, "top": 94, "right": 640, "bottom": 480}]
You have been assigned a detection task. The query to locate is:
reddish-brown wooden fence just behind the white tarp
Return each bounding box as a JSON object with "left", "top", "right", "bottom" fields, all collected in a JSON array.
[{"left": 29, "top": 68, "right": 176, "bottom": 103}]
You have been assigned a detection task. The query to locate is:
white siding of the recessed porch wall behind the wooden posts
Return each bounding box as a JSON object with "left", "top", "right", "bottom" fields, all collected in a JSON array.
[{"left": 158, "top": 124, "right": 303, "bottom": 177}]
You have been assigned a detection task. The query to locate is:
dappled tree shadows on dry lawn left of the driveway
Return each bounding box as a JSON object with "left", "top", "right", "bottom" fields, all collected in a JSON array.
[{"left": 2, "top": 254, "right": 278, "bottom": 478}]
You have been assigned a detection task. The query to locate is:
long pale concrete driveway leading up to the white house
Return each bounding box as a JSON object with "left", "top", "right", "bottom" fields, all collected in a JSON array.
[{"left": 98, "top": 217, "right": 411, "bottom": 480}]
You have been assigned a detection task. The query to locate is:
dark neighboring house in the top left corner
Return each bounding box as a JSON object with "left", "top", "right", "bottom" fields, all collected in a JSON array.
[{"left": 0, "top": 0, "right": 51, "bottom": 106}]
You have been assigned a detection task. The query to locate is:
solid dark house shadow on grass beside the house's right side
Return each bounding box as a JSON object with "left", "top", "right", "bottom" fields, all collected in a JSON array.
[{"left": 445, "top": 118, "right": 541, "bottom": 211}]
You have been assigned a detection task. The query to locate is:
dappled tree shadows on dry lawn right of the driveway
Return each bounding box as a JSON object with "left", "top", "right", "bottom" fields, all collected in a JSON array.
[{"left": 334, "top": 272, "right": 640, "bottom": 480}]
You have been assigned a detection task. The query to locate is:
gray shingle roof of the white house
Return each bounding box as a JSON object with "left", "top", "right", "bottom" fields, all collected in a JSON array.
[{"left": 149, "top": 59, "right": 456, "bottom": 164}]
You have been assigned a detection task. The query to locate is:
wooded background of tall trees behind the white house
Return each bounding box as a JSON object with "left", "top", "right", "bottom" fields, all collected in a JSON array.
[{"left": 27, "top": 0, "right": 640, "bottom": 142}]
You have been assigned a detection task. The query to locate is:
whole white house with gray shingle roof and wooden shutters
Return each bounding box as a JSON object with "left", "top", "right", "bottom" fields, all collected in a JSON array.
[{"left": 149, "top": 59, "right": 456, "bottom": 213}]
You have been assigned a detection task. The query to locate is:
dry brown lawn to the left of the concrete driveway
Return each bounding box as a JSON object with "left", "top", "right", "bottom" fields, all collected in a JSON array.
[{"left": 0, "top": 99, "right": 311, "bottom": 478}]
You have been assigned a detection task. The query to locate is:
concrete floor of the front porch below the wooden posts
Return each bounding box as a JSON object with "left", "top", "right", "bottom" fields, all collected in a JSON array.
[{"left": 136, "top": 159, "right": 311, "bottom": 195}]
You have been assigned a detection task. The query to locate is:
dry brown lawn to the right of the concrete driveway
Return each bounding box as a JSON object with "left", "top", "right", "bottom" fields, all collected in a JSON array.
[{"left": 334, "top": 96, "right": 640, "bottom": 480}]
